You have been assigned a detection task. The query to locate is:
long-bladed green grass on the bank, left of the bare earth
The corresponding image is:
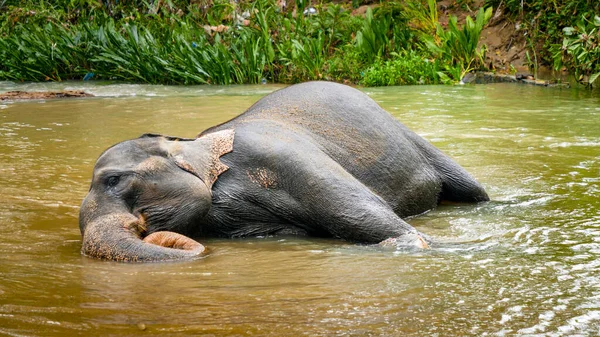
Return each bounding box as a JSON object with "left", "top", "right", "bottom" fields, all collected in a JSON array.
[{"left": 0, "top": 0, "right": 496, "bottom": 85}]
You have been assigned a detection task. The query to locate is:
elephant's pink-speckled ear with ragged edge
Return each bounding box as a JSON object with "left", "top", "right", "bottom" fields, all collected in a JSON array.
[{"left": 169, "top": 129, "right": 235, "bottom": 188}]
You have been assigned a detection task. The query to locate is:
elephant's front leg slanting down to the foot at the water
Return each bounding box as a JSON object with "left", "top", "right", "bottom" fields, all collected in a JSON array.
[{"left": 276, "top": 150, "right": 426, "bottom": 247}]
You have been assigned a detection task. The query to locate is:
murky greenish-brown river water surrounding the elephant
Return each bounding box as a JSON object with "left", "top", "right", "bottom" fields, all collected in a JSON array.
[{"left": 0, "top": 82, "right": 600, "bottom": 336}]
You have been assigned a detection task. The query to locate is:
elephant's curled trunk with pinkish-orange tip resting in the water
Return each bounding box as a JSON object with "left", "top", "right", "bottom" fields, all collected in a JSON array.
[{"left": 81, "top": 213, "right": 205, "bottom": 262}]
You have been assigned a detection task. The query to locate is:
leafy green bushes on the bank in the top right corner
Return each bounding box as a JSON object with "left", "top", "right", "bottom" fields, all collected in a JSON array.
[{"left": 485, "top": 0, "right": 600, "bottom": 87}]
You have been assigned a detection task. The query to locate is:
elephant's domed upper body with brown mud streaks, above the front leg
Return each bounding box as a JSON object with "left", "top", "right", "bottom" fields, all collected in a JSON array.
[{"left": 209, "top": 81, "right": 427, "bottom": 174}]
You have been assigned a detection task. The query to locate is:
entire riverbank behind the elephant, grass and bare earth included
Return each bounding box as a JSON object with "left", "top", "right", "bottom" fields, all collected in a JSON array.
[{"left": 0, "top": 0, "right": 600, "bottom": 86}]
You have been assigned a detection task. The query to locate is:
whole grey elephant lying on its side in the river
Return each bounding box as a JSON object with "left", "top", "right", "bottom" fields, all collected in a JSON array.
[{"left": 80, "top": 82, "right": 488, "bottom": 261}]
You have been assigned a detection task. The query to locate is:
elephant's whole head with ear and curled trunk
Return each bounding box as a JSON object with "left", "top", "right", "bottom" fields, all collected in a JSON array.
[{"left": 79, "top": 130, "right": 234, "bottom": 261}]
